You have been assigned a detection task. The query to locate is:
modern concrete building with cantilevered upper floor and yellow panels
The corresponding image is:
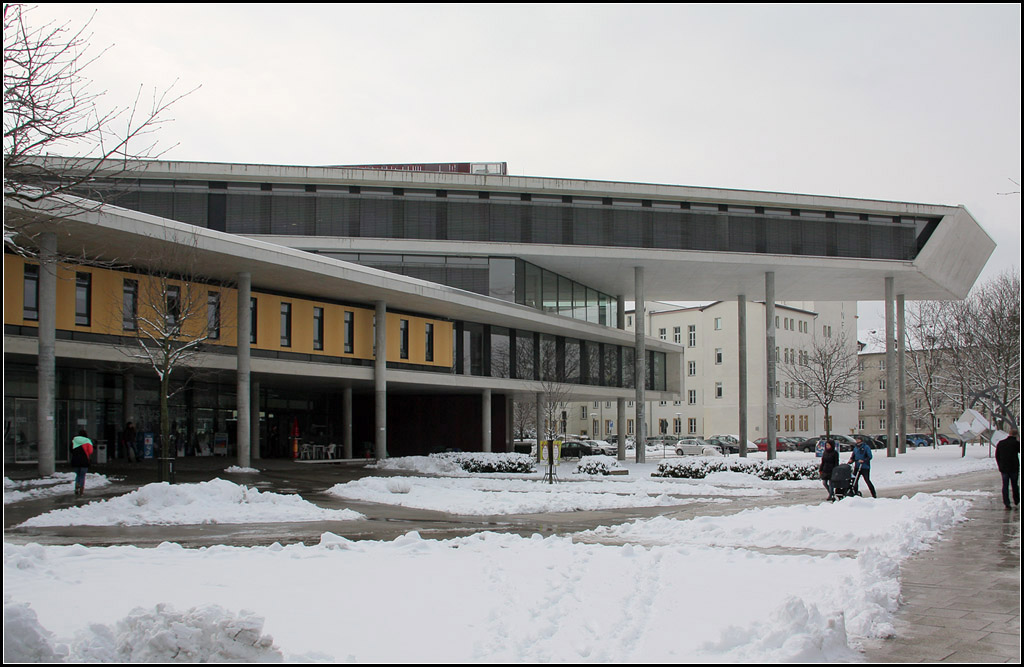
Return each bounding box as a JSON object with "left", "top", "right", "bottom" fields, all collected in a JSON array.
[{"left": 4, "top": 158, "right": 994, "bottom": 467}]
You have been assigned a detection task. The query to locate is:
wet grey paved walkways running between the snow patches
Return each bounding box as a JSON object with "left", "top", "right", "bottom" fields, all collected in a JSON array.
[{"left": 4, "top": 459, "right": 1021, "bottom": 663}]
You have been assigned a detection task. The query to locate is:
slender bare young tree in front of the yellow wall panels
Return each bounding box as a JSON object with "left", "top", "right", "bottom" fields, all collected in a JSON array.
[{"left": 121, "top": 235, "right": 234, "bottom": 482}]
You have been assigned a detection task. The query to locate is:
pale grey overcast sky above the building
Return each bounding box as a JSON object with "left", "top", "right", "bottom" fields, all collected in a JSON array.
[{"left": 29, "top": 4, "right": 1021, "bottom": 326}]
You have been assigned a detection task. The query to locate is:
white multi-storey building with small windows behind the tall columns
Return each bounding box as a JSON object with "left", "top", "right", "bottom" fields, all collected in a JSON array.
[{"left": 566, "top": 301, "right": 858, "bottom": 441}]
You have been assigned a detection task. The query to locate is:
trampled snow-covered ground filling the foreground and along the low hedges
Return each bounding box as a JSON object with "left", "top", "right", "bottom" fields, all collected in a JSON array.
[{"left": 3, "top": 448, "right": 994, "bottom": 662}]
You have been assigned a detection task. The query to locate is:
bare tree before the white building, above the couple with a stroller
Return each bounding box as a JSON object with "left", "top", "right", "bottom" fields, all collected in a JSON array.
[{"left": 781, "top": 333, "right": 859, "bottom": 437}]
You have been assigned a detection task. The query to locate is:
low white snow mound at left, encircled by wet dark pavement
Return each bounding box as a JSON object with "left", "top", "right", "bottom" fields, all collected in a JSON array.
[{"left": 22, "top": 480, "right": 362, "bottom": 527}]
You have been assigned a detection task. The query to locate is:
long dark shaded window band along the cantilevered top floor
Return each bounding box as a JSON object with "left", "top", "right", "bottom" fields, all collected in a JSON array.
[{"left": 96, "top": 179, "right": 938, "bottom": 260}]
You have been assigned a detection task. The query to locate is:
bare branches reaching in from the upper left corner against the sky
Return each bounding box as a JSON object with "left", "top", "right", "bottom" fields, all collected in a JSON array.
[{"left": 3, "top": 4, "right": 193, "bottom": 247}]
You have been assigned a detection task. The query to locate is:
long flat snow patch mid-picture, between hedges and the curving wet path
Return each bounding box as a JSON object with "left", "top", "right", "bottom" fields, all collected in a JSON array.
[{"left": 328, "top": 477, "right": 728, "bottom": 516}]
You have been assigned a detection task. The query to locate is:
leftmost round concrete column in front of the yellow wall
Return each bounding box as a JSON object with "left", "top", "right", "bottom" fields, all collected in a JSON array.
[{"left": 36, "top": 232, "right": 56, "bottom": 476}]
